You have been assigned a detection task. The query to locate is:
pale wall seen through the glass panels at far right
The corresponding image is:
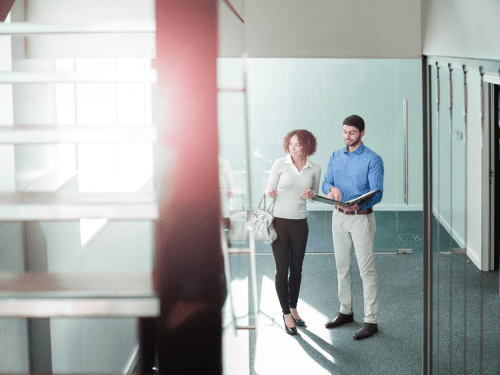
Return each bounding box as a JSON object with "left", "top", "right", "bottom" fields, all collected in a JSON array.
[{"left": 430, "top": 64, "right": 496, "bottom": 271}]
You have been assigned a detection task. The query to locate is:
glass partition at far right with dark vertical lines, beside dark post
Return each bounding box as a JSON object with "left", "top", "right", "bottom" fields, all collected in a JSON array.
[{"left": 424, "top": 57, "right": 500, "bottom": 374}]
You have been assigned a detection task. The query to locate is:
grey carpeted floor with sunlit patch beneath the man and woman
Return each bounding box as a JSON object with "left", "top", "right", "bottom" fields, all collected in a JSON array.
[{"left": 223, "top": 212, "right": 500, "bottom": 375}]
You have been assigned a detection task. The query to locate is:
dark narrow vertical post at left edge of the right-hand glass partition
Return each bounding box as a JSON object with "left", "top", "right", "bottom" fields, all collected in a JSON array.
[{"left": 422, "top": 56, "right": 432, "bottom": 375}]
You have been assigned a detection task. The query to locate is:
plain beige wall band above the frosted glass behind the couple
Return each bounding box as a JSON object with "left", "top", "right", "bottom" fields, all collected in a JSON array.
[{"left": 244, "top": 0, "right": 421, "bottom": 58}]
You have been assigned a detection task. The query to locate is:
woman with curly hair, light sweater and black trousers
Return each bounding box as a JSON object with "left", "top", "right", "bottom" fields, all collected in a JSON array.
[{"left": 266, "top": 129, "right": 321, "bottom": 335}]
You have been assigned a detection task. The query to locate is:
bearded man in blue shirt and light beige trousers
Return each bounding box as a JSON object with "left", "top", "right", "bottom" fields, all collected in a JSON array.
[{"left": 322, "top": 115, "right": 384, "bottom": 340}]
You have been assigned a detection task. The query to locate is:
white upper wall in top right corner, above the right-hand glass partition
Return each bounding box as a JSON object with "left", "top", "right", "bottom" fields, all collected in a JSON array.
[{"left": 422, "top": 0, "right": 500, "bottom": 60}]
